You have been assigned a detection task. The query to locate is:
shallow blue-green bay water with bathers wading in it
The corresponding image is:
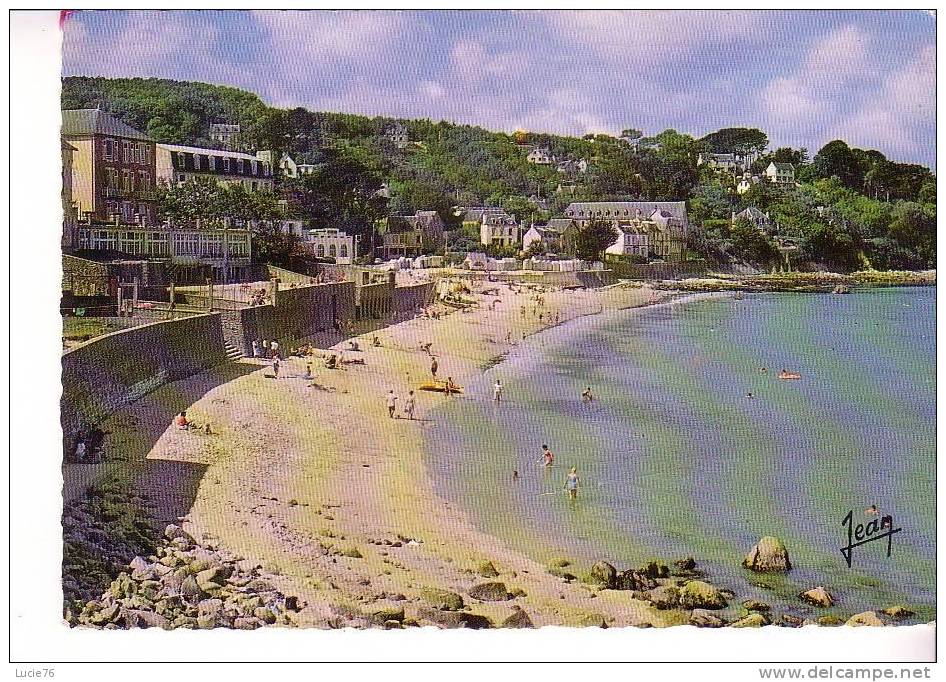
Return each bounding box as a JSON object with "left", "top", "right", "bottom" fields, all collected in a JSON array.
[{"left": 428, "top": 288, "right": 936, "bottom": 620}]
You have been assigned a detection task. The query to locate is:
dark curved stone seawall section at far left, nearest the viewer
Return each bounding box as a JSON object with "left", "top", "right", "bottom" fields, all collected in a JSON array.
[{"left": 60, "top": 313, "right": 226, "bottom": 454}]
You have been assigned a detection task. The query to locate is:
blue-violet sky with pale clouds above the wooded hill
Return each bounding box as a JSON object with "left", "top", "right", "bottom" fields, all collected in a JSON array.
[{"left": 63, "top": 10, "right": 936, "bottom": 167}]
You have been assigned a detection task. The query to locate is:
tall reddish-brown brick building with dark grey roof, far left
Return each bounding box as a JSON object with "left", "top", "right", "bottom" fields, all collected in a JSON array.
[{"left": 62, "top": 109, "right": 157, "bottom": 225}]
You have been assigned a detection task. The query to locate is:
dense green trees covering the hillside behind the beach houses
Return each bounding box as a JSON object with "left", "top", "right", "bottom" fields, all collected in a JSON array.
[{"left": 62, "top": 77, "right": 936, "bottom": 270}]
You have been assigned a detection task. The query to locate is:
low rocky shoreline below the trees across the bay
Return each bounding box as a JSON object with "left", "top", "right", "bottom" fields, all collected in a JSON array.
[{"left": 651, "top": 270, "right": 936, "bottom": 293}]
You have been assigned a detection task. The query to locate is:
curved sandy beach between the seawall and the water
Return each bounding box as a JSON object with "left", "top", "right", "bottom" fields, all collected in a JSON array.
[{"left": 75, "top": 282, "right": 683, "bottom": 627}]
